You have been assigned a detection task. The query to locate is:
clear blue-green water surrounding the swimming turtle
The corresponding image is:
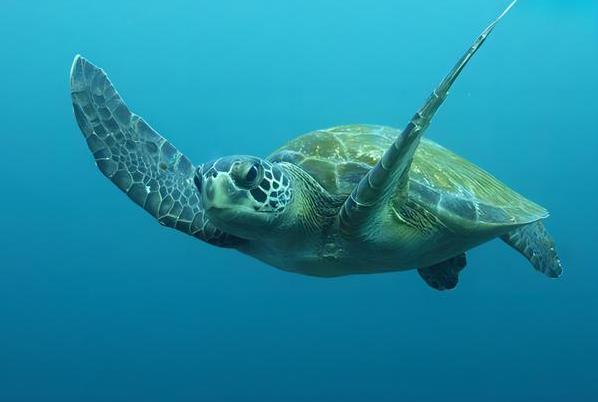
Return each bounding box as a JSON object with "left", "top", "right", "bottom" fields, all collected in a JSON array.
[{"left": 0, "top": 0, "right": 598, "bottom": 402}]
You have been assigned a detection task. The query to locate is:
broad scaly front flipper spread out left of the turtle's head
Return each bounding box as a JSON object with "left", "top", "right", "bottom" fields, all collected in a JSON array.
[{"left": 70, "top": 56, "right": 238, "bottom": 246}]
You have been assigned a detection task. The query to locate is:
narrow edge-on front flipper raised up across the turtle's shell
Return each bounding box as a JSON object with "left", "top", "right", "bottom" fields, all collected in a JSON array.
[{"left": 339, "top": 0, "right": 517, "bottom": 236}]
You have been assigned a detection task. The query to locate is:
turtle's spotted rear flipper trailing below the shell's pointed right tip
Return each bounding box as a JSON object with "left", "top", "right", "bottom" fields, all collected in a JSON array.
[{"left": 501, "top": 221, "right": 563, "bottom": 278}]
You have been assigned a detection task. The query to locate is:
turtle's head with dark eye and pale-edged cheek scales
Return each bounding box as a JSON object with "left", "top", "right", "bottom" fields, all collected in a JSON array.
[{"left": 194, "top": 155, "right": 293, "bottom": 239}]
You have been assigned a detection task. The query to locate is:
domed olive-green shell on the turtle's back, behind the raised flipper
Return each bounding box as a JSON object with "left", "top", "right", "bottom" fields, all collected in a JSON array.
[{"left": 269, "top": 125, "right": 548, "bottom": 225}]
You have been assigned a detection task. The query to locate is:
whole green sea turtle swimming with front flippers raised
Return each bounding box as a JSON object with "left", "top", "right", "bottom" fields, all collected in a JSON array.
[{"left": 70, "top": 2, "right": 562, "bottom": 290}]
